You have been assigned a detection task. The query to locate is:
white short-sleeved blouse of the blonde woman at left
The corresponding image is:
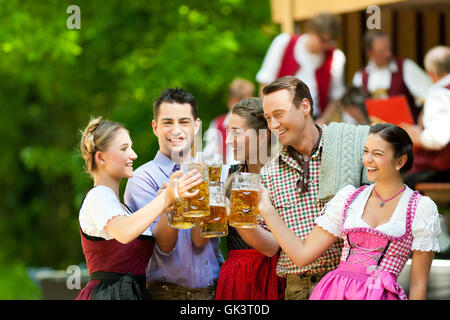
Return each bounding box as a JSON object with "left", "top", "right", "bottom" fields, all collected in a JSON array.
[{"left": 79, "top": 186, "right": 129, "bottom": 240}]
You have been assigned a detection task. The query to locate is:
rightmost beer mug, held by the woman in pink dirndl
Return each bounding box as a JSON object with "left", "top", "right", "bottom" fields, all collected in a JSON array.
[{"left": 228, "top": 172, "right": 260, "bottom": 228}]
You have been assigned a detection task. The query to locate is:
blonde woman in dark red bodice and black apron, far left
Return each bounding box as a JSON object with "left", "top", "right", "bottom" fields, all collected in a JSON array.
[{"left": 77, "top": 117, "right": 201, "bottom": 300}]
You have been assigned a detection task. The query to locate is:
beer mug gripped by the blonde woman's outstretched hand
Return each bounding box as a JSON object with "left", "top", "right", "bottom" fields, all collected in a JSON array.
[{"left": 181, "top": 162, "right": 210, "bottom": 218}]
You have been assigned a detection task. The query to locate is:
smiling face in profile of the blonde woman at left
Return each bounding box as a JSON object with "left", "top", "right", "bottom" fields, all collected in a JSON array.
[{"left": 100, "top": 128, "right": 137, "bottom": 180}]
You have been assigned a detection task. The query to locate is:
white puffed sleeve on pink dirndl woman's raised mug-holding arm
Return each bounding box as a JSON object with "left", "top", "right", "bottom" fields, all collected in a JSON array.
[{"left": 316, "top": 185, "right": 355, "bottom": 237}]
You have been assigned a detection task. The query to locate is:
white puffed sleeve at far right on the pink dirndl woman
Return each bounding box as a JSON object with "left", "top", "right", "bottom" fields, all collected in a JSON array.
[{"left": 411, "top": 196, "right": 441, "bottom": 252}]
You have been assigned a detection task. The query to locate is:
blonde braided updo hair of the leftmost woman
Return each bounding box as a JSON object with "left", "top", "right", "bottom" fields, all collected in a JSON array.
[{"left": 80, "top": 117, "right": 125, "bottom": 175}]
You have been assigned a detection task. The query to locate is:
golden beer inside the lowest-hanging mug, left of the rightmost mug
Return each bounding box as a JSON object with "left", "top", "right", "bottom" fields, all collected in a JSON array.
[{"left": 199, "top": 206, "right": 228, "bottom": 238}]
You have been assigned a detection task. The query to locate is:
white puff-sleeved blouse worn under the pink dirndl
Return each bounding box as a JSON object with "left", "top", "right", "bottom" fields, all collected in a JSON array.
[{"left": 316, "top": 184, "right": 441, "bottom": 252}]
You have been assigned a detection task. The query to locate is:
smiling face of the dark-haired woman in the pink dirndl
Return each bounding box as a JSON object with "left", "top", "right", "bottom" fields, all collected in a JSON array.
[{"left": 363, "top": 133, "right": 405, "bottom": 182}]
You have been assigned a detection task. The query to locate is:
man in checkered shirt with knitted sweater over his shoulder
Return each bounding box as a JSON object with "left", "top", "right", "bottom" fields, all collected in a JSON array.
[{"left": 239, "top": 76, "right": 368, "bottom": 300}]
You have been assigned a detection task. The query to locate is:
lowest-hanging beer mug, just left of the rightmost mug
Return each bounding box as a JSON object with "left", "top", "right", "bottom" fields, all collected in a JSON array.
[{"left": 199, "top": 181, "right": 228, "bottom": 238}]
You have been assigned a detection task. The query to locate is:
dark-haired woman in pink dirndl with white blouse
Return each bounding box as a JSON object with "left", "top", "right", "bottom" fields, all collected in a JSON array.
[{"left": 260, "top": 124, "right": 440, "bottom": 300}]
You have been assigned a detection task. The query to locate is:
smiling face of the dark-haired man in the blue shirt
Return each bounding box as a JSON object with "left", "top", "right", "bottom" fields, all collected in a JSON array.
[{"left": 152, "top": 102, "right": 200, "bottom": 159}]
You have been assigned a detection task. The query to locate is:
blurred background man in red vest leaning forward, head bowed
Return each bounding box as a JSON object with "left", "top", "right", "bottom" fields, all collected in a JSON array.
[{"left": 256, "top": 13, "right": 346, "bottom": 125}]
